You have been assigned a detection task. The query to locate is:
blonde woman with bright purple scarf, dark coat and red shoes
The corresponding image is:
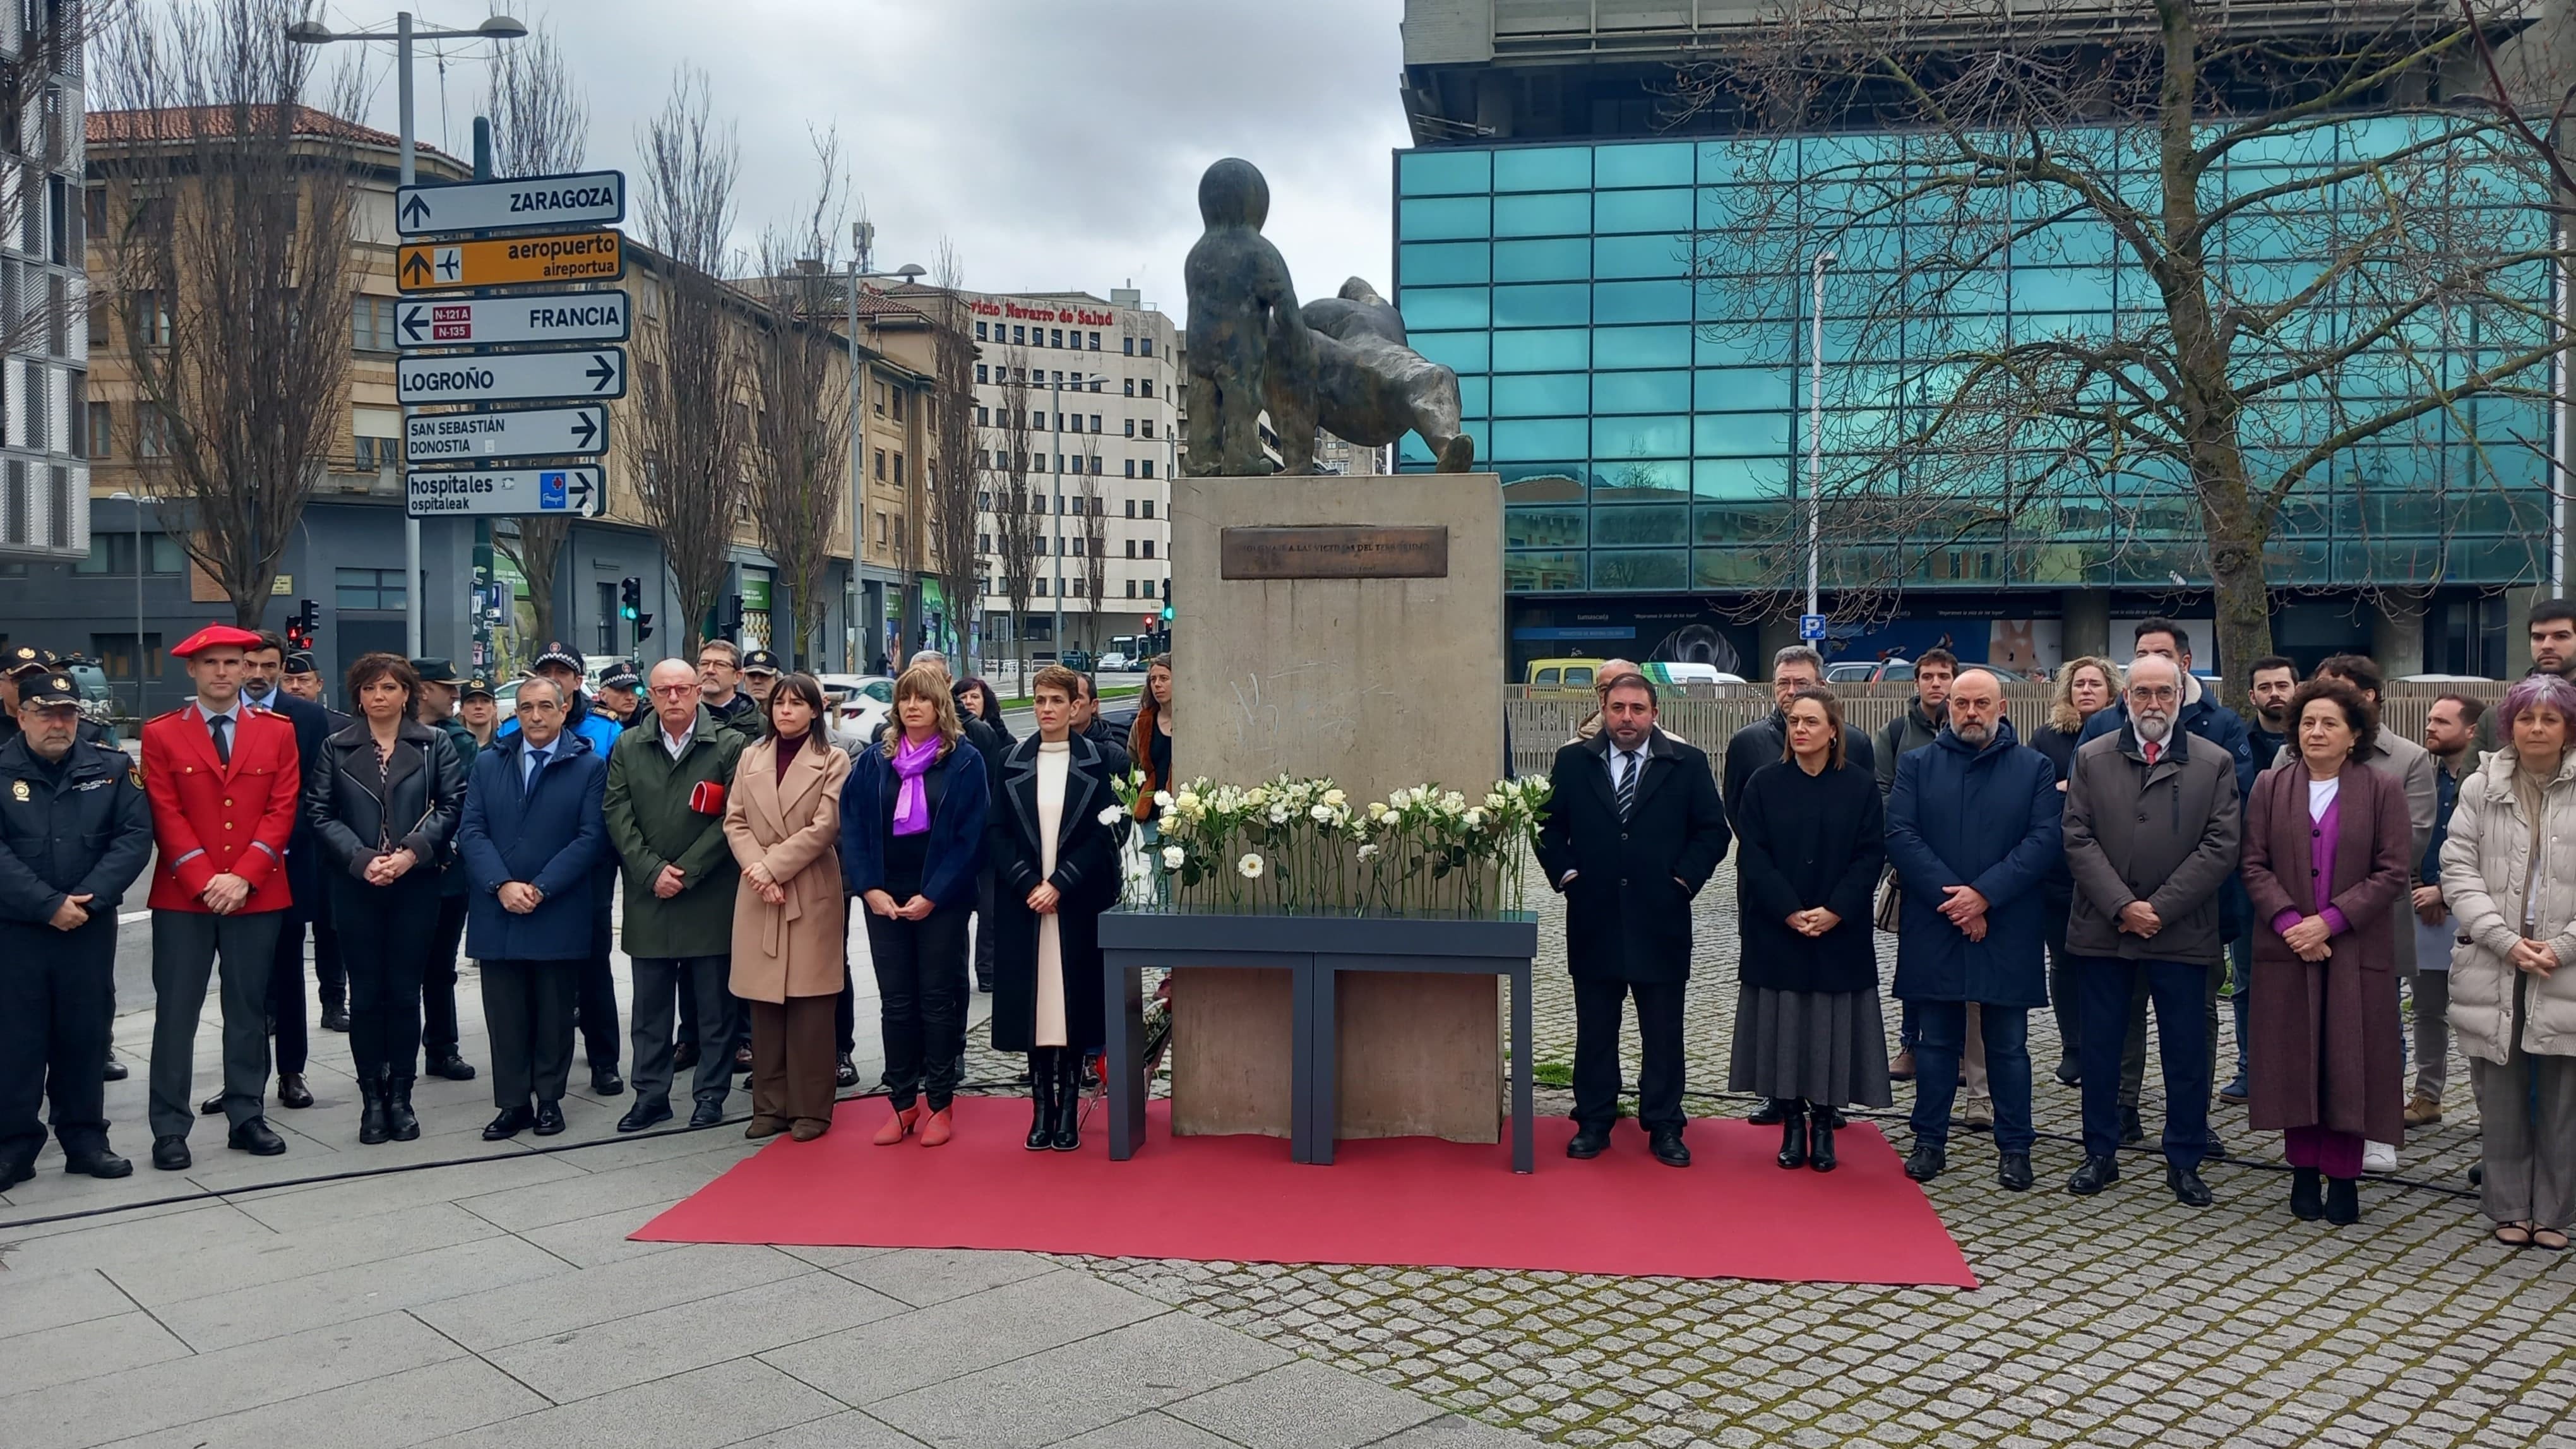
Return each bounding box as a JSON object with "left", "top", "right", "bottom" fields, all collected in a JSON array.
[{"left": 840, "top": 665, "right": 992, "bottom": 1147}]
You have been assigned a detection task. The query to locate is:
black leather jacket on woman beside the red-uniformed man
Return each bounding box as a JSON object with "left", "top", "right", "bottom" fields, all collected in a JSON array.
[{"left": 304, "top": 719, "right": 466, "bottom": 880}]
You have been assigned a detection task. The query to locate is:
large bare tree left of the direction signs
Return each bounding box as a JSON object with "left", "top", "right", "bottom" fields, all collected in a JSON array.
[{"left": 90, "top": 0, "right": 363, "bottom": 626}]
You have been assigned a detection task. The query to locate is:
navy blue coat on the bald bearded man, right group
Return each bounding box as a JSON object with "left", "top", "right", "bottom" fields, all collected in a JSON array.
[{"left": 1888, "top": 719, "right": 2063, "bottom": 1006}]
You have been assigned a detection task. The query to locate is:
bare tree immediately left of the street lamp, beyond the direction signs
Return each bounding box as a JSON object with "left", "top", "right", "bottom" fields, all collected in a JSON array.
[{"left": 749, "top": 131, "right": 858, "bottom": 671}]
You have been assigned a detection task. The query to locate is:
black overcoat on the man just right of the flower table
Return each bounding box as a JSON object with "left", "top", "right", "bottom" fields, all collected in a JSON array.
[{"left": 1538, "top": 730, "right": 1731, "bottom": 982}]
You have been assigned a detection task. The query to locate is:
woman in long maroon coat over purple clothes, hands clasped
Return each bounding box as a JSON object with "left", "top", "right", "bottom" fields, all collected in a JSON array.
[{"left": 2244, "top": 678, "right": 2414, "bottom": 1225}]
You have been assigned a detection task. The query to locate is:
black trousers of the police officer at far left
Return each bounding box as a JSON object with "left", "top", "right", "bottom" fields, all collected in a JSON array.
[{"left": 0, "top": 910, "right": 116, "bottom": 1166}]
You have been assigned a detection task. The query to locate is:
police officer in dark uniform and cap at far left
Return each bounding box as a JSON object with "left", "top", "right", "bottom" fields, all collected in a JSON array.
[{"left": 0, "top": 676, "right": 152, "bottom": 1191}]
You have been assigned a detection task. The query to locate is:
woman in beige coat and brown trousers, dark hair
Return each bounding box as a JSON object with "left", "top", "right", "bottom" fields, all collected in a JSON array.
[{"left": 724, "top": 673, "right": 850, "bottom": 1142}]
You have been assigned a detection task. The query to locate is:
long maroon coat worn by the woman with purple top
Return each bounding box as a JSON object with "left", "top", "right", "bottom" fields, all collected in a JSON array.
[{"left": 2244, "top": 761, "right": 2414, "bottom": 1142}]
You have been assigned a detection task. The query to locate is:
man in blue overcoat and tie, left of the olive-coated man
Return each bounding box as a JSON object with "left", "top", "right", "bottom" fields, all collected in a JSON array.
[{"left": 456, "top": 678, "right": 608, "bottom": 1142}]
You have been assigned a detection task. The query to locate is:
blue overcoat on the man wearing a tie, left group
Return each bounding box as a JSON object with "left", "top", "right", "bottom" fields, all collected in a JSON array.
[{"left": 456, "top": 730, "right": 608, "bottom": 962}]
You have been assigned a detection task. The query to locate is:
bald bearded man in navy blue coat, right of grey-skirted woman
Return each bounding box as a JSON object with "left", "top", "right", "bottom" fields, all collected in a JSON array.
[{"left": 1888, "top": 671, "right": 2061, "bottom": 1191}]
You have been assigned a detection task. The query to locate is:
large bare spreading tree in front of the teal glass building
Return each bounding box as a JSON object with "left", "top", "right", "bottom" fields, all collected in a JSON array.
[{"left": 1679, "top": 0, "right": 2566, "bottom": 686}]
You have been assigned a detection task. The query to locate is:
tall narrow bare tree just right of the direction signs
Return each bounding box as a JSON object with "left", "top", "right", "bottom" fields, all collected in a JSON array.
[{"left": 636, "top": 67, "right": 749, "bottom": 650}]
